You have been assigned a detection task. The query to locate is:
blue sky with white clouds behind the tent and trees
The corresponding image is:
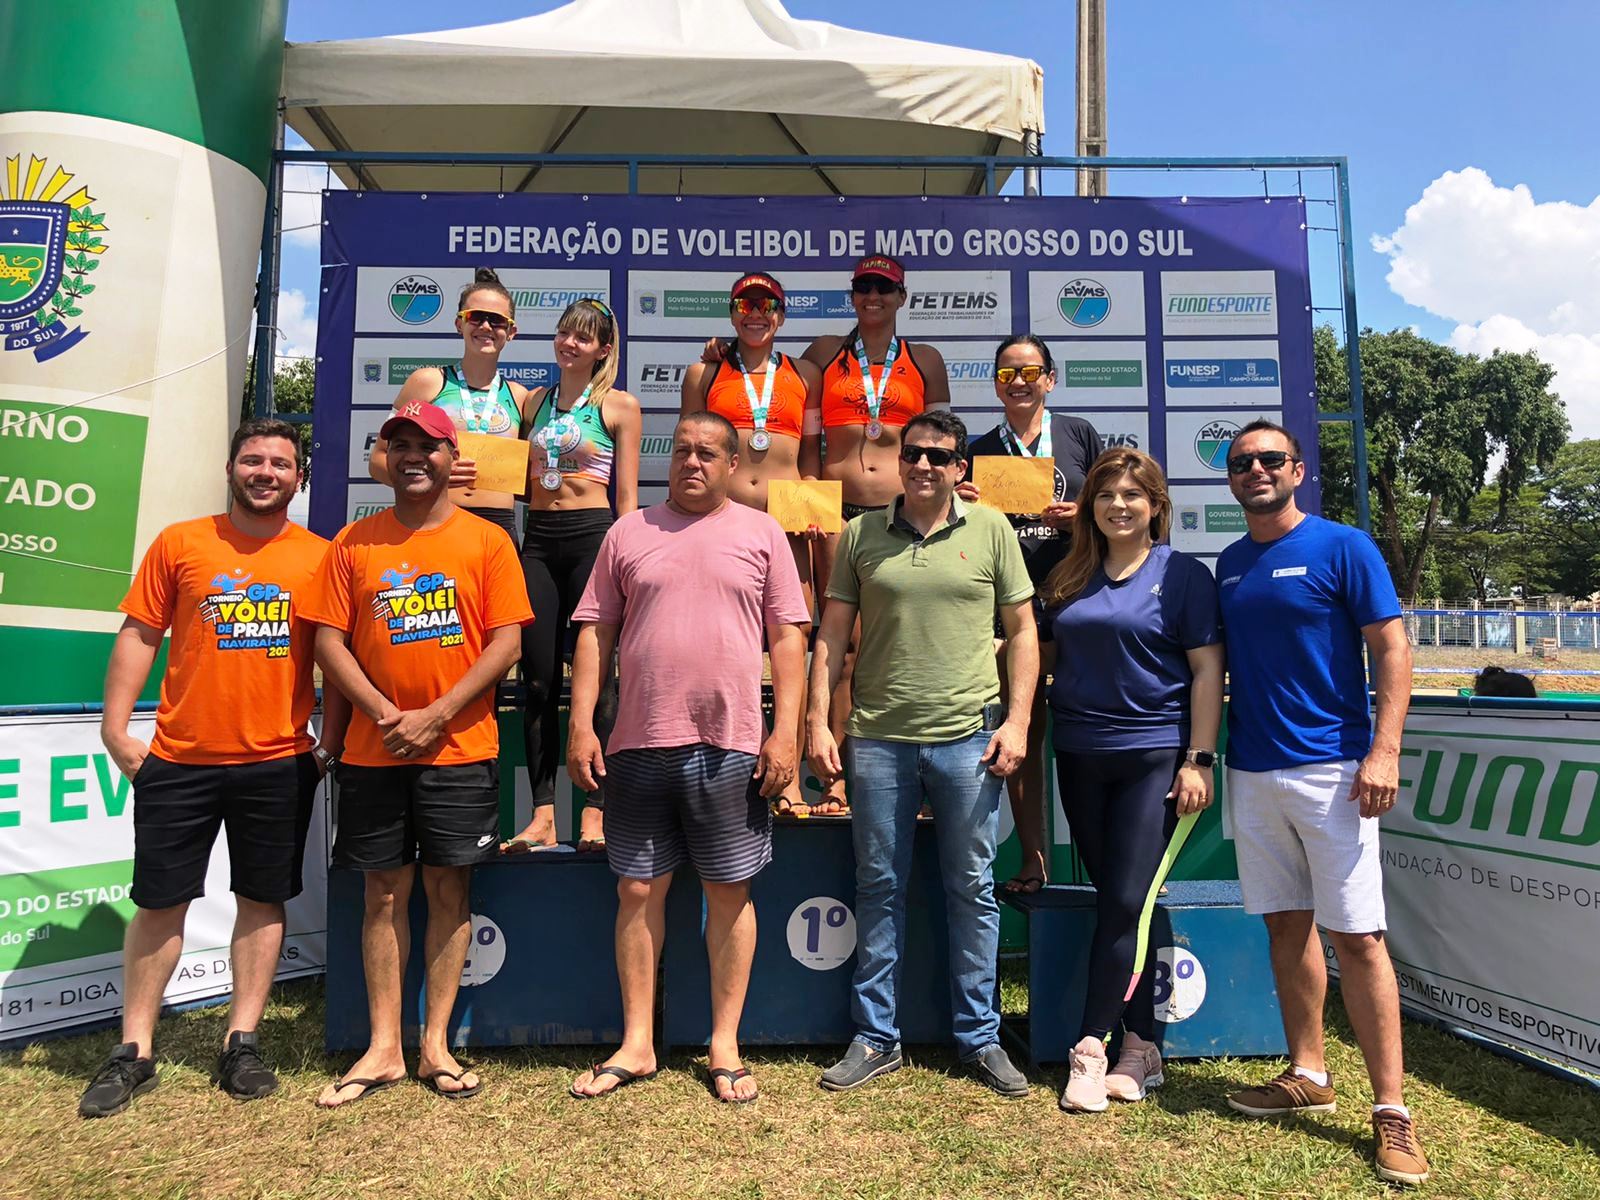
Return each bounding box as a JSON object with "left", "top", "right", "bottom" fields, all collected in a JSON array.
[{"left": 283, "top": 0, "right": 1600, "bottom": 437}]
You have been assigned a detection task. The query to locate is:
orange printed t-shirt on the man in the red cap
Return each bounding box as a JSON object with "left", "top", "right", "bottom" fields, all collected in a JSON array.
[{"left": 302, "top": 509, "right": 533, "bottom": 766}]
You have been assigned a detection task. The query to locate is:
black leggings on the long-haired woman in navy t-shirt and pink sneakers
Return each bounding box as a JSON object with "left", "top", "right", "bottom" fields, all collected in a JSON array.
[{"left": 1056, "top": 747, "right": 1184, "bottom": 1042}]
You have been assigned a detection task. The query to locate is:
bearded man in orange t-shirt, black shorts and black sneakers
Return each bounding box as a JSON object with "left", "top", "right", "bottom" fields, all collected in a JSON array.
[{"left": 78, "top": 421, "right": 349, "bottom": 1117}]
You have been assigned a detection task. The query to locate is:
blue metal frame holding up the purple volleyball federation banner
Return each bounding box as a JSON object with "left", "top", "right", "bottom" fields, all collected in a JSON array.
[{"left": 256, "top": 149, "right": 1371, "bottom": 531}]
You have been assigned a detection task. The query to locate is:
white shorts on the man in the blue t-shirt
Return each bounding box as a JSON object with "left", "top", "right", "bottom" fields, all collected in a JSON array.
[{"left": 1227, "top": 760, "right": 1387, "bottom": 933}]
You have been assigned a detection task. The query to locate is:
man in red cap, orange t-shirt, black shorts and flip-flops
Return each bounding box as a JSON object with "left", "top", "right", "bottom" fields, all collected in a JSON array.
[{"left": 302, "top": 402, "right": 533, "bottom": 1109}]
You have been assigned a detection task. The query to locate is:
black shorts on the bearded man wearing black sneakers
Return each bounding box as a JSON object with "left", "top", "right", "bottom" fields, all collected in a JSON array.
[{"left": 133, "top": 754, "right": 322, "bottom": 909}]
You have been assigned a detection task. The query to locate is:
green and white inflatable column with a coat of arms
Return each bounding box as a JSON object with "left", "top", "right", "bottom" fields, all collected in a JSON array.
[{"left": 0, "top": 0, "right": 286, "bottom": 704}]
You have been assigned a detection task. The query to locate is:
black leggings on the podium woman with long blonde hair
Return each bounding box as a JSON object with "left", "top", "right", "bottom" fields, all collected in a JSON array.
[{"left": 522, "top": 509, "right": 616, "bottom": 808}]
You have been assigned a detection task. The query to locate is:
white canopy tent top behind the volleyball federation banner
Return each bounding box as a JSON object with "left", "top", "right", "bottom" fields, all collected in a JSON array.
[{"left": 283, "top": 0, "right": 1045, "bottom": 195}]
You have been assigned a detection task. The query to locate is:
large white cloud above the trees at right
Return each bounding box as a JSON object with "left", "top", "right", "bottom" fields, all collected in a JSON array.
[{"left": 1373, "top": 166, "right": 1600, "bottom": 437}]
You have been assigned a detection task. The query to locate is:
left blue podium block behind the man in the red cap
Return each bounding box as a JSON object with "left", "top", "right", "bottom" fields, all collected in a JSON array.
[{"left": 325, "top": 846, "right": 622, "bottom": 1051}]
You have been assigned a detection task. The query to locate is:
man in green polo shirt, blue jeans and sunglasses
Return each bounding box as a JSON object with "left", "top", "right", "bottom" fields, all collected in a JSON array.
[{"left": 806, "top": 410, "right": 1038, "bottom": 1096}]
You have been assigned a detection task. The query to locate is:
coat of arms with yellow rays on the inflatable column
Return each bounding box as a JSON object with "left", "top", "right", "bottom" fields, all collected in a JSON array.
[{"left": 0, "top": 154, "right": 107, "bottom": 362}]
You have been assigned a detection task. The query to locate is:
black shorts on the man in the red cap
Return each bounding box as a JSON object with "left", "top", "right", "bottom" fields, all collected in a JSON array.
[{"left": 333, "top": 758, "right": 499, "bottom": 870}]
